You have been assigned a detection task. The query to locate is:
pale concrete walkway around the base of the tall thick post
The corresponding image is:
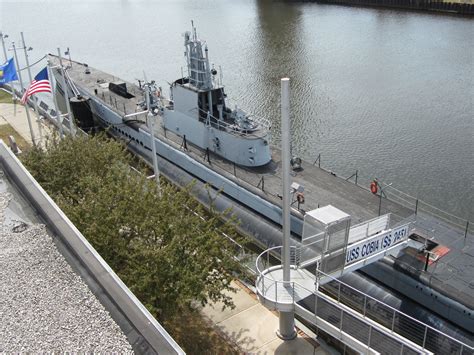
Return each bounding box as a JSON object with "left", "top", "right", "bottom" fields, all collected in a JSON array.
[{"left": 202, "top": 282, "right": 331, "bottom": 355}]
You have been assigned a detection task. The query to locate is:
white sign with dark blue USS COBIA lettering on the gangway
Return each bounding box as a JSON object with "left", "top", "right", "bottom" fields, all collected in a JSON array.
[{"left": 345, "top": 224, "right": 408, "bottom": 265}]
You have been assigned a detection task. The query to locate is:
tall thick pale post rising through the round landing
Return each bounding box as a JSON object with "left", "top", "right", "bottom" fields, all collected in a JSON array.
[{"left": 278, "top": 78, "right": 296, "bottom": 340}]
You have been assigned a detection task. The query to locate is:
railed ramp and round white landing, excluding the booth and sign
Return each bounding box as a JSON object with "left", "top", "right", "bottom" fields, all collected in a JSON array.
[{"left": 256, "top": 247, "right": 474, "bottom": 354}]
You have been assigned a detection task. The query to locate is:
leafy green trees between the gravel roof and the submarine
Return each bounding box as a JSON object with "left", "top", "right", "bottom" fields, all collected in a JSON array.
[{"left": 23, "top": 135, "right": 242, "bottom": 318}]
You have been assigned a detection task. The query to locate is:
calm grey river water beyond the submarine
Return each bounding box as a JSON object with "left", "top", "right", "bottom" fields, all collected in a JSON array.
[{"left": 0, "top": 0, "right": 474, "bottom": 221}]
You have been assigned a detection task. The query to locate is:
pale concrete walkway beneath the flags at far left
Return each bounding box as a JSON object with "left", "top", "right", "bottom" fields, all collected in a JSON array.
[{"left": 0, "top": 103, "right": 52, "bottom": 144}]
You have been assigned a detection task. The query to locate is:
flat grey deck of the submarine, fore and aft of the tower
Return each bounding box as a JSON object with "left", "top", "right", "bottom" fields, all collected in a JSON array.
[{"left": 50, "top": 55, "right": 474, "bottom": 309}]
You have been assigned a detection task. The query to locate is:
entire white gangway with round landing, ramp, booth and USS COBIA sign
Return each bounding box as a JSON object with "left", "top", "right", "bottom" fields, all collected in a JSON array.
[{"left": 256, "top": 206, "right": 474, "bottom": 354}]
